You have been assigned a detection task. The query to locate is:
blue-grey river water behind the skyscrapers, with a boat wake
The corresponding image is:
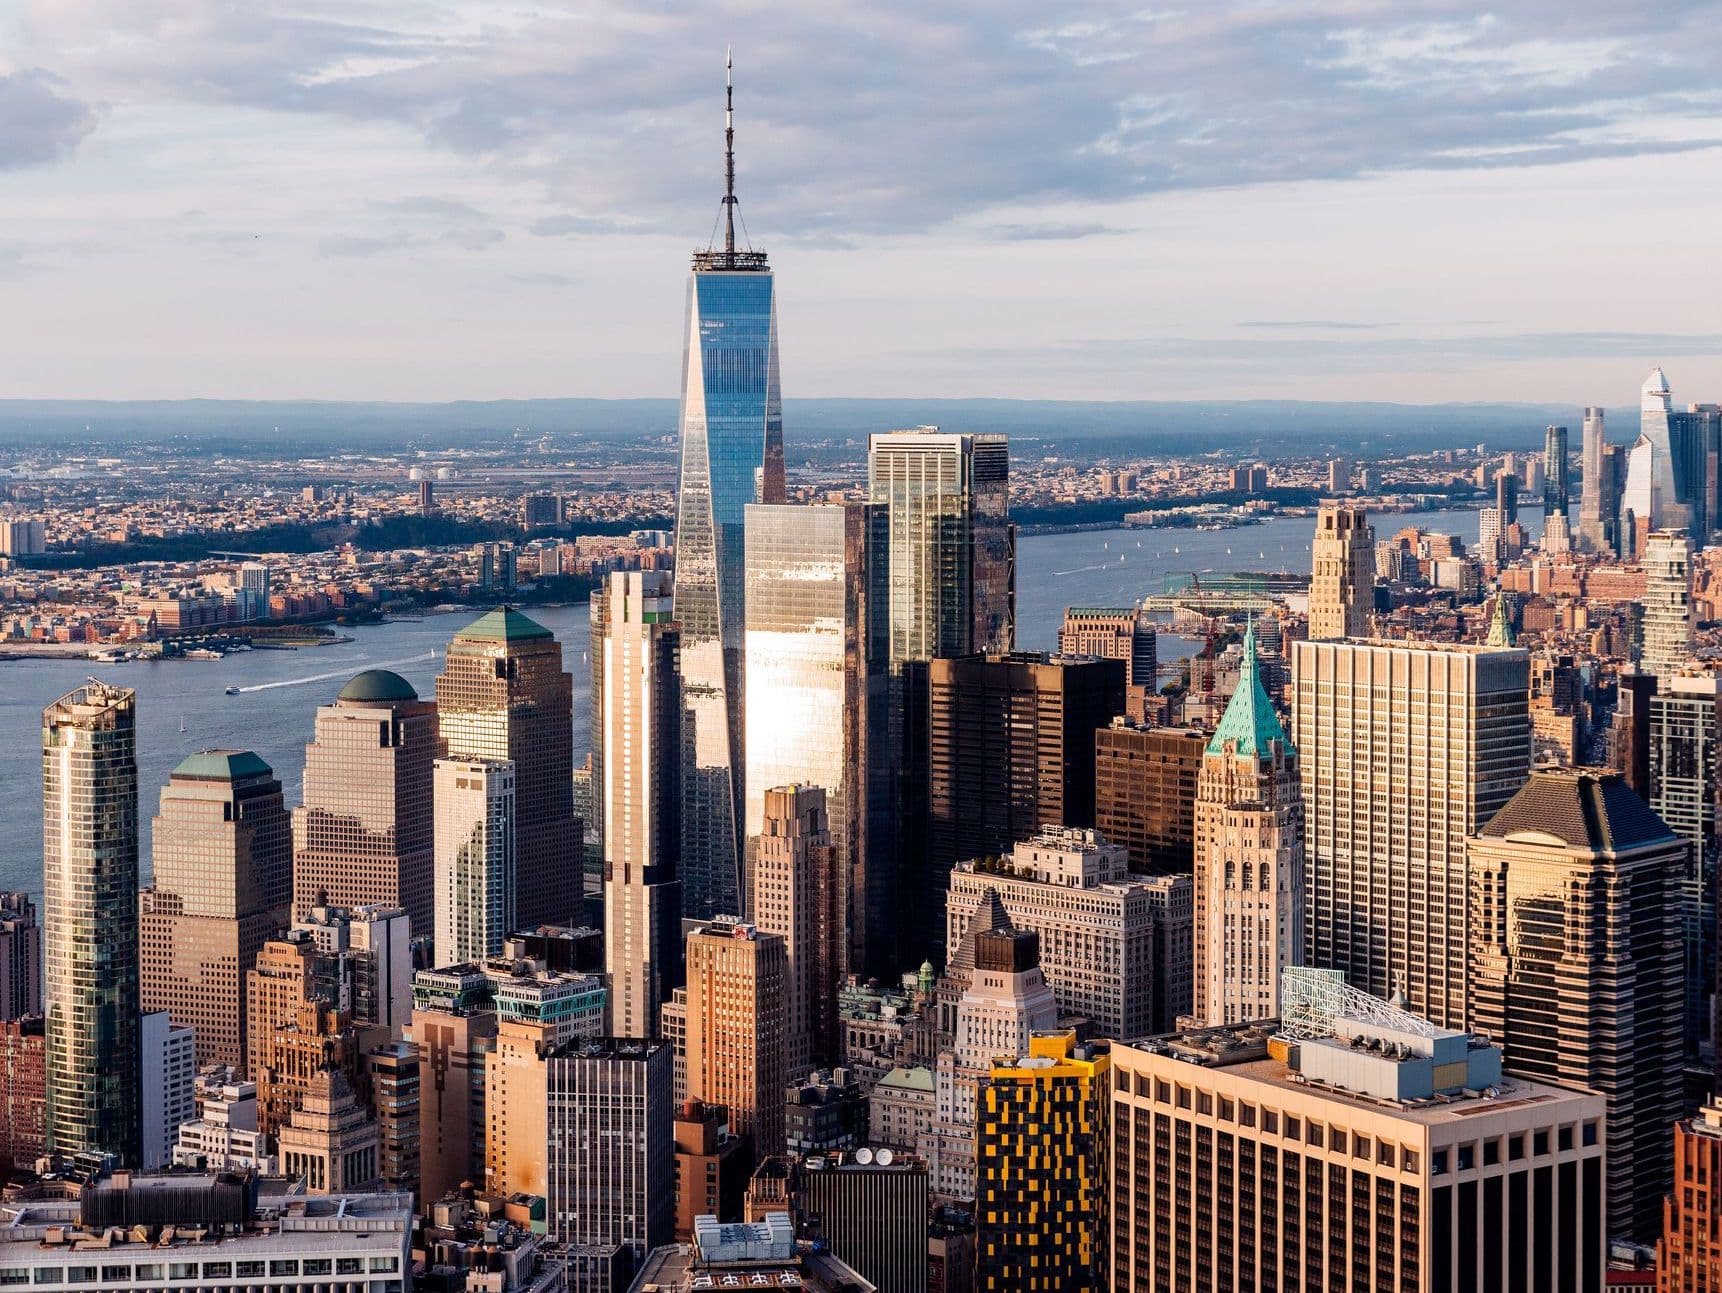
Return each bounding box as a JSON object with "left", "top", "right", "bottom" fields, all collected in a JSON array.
[{"left": 0, "top": 508, "right": 1515, "bottom": 894}]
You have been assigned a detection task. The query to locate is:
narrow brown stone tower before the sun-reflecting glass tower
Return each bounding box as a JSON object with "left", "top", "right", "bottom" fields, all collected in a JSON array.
[{"left": 749, "top": 788, "right": 847, "bottom": 1080}]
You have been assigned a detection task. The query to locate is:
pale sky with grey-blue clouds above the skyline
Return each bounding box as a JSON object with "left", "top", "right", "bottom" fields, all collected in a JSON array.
[{"left": 0, "top": 0, "right": 1722, "bottom": 405}]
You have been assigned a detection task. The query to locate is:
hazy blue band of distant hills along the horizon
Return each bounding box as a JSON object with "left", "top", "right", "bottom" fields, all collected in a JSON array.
[{"left": 0, "top": 398, "right": 1611, "bottom": 458}]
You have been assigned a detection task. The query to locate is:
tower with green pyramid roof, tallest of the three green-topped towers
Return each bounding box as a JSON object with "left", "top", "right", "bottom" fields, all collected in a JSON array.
[{"left": 436, "top": 606, "right": 585, "bottom": 928}]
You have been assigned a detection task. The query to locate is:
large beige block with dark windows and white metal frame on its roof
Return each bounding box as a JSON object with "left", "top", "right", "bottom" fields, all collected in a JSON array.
[{"left": 1107, "top": 971, "right": 1607, "bottom": 1293}]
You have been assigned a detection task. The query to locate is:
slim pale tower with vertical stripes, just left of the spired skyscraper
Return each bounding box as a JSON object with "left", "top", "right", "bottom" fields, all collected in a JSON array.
[{"left": 592, "top": 570, "right": 682, "bottom": 1036}]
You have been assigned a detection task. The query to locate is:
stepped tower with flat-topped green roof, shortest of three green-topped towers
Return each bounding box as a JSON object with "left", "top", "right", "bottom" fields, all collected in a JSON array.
[{"left": 138, "top": 751, "right": 293, "bottom": 1067}]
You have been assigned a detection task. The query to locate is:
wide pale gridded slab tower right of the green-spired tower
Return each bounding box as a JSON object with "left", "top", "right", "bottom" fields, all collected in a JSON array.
[{"left": 1292, "top": 642, "right": 1531, "bottom": 1028}]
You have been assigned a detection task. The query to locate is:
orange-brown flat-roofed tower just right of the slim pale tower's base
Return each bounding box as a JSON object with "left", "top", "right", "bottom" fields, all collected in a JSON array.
[{"left": 682, "top": 919, "right": 789, "bottom": 1162}]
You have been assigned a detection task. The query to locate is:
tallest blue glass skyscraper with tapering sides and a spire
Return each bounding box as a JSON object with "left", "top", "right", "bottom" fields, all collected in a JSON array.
[{"left": 675, "top": 60, "right": 784, "bottom": 918}]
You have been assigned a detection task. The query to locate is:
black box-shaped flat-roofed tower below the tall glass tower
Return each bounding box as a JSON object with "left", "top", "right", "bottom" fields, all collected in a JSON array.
[{"left": 929, "top": 651, "right": 1124, "bottom": 947}]
